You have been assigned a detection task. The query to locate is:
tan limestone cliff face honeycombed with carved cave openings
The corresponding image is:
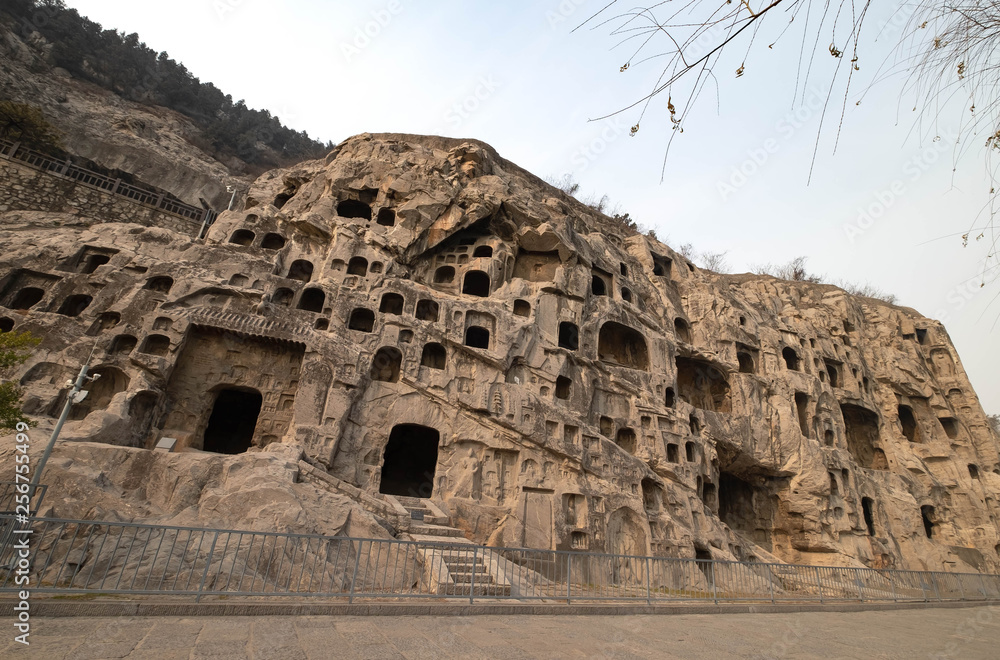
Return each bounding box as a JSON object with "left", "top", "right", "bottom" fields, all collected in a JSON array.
[{"left": 0, "top": 135, "right": 1000, "bottom": 571}]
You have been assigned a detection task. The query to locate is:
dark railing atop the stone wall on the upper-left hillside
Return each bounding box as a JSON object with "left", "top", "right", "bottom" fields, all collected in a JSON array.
[{"left": 0, "top": 140, "right": 216, "bottom": 224}]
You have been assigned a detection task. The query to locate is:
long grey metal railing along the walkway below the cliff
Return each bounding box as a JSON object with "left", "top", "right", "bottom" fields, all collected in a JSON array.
[{"left": 0, "top": 515, "right": 1000, "bottom": 603}]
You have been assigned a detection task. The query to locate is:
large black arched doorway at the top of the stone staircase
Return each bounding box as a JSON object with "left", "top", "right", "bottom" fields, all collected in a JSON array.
[{"left": 379, "top": 424, "right": 441, "bottom": 497}]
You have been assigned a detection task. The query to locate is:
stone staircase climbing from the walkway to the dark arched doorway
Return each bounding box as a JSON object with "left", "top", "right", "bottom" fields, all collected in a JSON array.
[{"left": 385, "top": 495, "right": 511, "bottom": 598}]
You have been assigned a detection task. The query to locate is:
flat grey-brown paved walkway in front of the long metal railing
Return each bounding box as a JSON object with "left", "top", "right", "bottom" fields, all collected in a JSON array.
[{"left": 0, "top": 606, "right": 1000, "bottom": 660}]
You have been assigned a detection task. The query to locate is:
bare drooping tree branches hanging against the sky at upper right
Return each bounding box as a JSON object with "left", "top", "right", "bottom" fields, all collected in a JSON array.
[{"left": 577, "top": 0, "right": 1000, "bottom": 282}]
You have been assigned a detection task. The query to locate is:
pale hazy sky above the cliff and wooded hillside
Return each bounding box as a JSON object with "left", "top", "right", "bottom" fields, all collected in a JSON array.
[{"left": 68, "top": 0, "right": 1000, "bottom": 413}]
